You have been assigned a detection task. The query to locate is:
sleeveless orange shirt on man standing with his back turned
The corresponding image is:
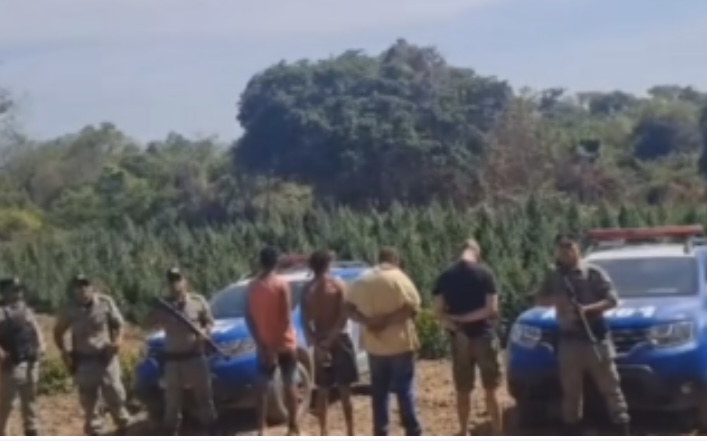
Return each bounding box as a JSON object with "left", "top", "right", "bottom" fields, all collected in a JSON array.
[{"left": 248, "top": 275, "right": 297, "bottom": 351}]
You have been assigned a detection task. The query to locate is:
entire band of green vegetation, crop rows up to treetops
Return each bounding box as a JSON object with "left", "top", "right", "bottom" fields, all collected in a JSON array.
[{"left": 0, "top": 41, "right": 707, "bottom": 319}]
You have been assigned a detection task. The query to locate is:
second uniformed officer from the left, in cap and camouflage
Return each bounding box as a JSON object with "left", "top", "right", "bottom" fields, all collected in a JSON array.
[{"left": 54, "top": 274, "right": 130, "bottom": 436}]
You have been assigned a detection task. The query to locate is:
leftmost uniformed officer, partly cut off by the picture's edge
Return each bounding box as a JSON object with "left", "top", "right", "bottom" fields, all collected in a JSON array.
[{"left": 0, "top": 278, "right": 45, "bottom": 436}]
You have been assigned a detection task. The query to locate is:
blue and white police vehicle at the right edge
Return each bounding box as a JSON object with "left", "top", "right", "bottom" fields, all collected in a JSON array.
[{"left": 506, "top": 226, "right": 707, "bottom": 427}]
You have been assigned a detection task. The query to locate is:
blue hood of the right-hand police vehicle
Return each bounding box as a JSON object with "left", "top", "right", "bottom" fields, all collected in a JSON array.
[{"left": 518, "top": 296, "right": 702, "bottom": 328}]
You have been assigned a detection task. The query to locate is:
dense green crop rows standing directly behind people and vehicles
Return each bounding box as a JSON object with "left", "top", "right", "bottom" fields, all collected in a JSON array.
[{"left": 6, "top": 199, "right": 707, "bottom": 320}]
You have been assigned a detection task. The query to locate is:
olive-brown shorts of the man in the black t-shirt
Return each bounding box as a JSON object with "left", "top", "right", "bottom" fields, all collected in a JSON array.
[{"left": 450, "top": 332, "right": 501, "bottom": 392}]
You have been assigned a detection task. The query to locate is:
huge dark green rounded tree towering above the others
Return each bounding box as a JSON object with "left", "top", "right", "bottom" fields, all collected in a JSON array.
[{"left": 234, "top": 40, "right": 511, "bottom": 205}]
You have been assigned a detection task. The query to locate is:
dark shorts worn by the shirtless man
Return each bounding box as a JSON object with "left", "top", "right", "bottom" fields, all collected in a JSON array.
[{"left": 314, "top": 334, "right": 359, "bottom": 388}]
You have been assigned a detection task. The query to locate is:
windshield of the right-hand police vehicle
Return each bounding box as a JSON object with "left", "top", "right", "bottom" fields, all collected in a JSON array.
[{"left": 591, "top": 256, "right": 699, "bottom": 298}]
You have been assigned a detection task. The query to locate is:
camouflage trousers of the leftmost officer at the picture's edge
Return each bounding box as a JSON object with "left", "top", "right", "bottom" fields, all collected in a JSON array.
[{"left": 0, "top": 362, "right": 39, "bottom": 436}]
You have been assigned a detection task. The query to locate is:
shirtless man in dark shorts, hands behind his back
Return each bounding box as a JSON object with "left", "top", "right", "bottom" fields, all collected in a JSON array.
[{"left": 302, "top": 251, "right": 358, "bottom": 436}]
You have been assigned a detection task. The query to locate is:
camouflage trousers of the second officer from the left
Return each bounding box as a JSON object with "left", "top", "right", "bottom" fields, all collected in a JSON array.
[{"left": 74, "top": 358, "right": 130, "bottom": 435}]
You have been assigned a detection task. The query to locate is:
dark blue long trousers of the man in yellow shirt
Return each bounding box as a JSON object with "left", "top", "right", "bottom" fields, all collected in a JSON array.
[{"left": 368, "top": 352, "right": 422, "bottom": 436}]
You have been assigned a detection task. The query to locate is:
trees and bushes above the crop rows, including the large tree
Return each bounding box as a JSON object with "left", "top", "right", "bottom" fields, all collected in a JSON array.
[{"left": 0, "top": 41, "right": 707, "bottom": 241}]
